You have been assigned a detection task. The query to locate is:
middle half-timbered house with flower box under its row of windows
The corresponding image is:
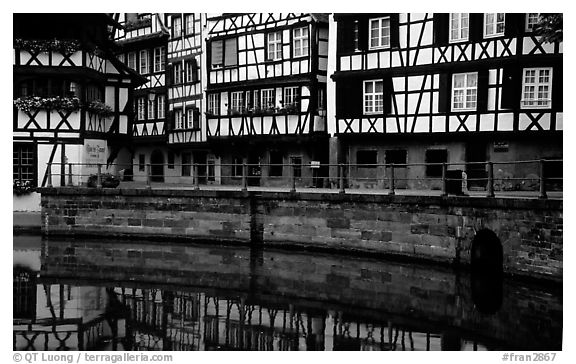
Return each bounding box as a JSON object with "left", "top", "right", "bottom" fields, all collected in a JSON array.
[{"left": 206, "top": 13, "right": 328, "bottom": 185}]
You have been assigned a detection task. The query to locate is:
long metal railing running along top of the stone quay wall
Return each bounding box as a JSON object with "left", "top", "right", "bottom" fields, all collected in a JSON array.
[{"left": 44, "top": 159, "right": 563, "bottom": 199}]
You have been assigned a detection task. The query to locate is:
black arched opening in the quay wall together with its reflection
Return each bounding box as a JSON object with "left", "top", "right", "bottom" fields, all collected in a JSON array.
[{"left": 470, "top": 229, "right": 503, "bottom": 314}]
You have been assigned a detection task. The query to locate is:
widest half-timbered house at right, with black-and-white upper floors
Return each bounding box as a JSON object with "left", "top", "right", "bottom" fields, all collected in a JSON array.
[{"left": 330, "top": 13, "right": 563, "bottom": 189}]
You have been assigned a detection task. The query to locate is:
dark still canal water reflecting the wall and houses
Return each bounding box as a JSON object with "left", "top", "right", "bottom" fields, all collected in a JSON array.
[{"left": 13, "top": 236, "right": 562, "bottom": 351}]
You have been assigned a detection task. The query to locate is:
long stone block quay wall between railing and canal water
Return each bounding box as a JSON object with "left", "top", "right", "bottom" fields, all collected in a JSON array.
[{"left": 42, "top": 187, "right": 563, "bottom": 281}]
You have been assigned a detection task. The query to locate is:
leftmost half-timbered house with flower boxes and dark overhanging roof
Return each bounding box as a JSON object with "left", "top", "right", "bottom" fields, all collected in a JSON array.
[{"left": 13, "top": 14, "right": 143, "bottom": 210}]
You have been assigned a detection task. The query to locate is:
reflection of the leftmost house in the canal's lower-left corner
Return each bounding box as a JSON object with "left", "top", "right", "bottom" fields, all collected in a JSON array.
[{"left": 13, "top": 280, "right": 126, "bottom": 350}]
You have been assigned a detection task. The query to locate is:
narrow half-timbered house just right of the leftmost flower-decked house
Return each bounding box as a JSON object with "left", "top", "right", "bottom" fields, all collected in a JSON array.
[{"left": 114, "top": 13, "right": 170, "bottom": 182}]
